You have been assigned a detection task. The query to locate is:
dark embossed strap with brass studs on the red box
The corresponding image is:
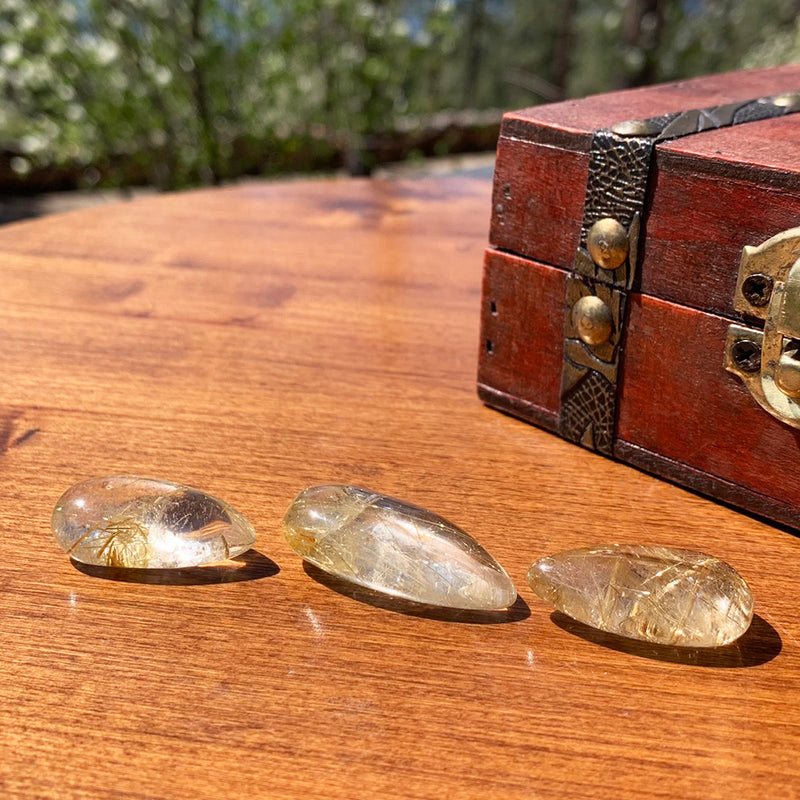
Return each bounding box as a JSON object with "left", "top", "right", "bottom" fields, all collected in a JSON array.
[{"left": 559, "top": 92, "right": 800, "bottom": 455}]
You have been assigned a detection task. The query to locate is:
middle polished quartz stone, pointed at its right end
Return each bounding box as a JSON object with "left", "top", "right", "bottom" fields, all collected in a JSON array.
[{"left": 283, "top": 486, "right": 517, "bottom": 610}]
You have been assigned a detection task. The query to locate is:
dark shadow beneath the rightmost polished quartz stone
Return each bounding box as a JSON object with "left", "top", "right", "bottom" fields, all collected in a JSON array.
[{"left": 550, "top": 611, "right": 783, "bottom": 669}]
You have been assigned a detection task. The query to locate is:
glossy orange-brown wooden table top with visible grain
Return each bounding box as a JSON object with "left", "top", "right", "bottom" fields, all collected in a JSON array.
[{"left": 0, "top": 177, "right": 800, "bottom": 800}]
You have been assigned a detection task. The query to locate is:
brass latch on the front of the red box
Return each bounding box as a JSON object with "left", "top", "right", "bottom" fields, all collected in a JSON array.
[{"left": 725, "top": 228, "right": 800, "bottom": 428}]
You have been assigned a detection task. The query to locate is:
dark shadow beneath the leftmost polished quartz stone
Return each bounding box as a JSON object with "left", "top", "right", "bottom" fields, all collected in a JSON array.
[{"left": 70, "top": 550, "right": 280, "bottom": 586}]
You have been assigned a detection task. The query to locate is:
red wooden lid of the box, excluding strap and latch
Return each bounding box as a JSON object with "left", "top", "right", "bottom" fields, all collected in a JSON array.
[{"left": 490, "top": 64, "right": 800, "bottom": 317}]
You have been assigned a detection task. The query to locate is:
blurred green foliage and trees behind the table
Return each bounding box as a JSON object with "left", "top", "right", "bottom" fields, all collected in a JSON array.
[{"left": 0, "top": 0, "right": 800, "bottom": 188}]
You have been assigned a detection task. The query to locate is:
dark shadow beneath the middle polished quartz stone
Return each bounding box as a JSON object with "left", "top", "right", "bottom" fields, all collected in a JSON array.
[{"left": 303, "top": 561, "right": 531, "bottom": 625}]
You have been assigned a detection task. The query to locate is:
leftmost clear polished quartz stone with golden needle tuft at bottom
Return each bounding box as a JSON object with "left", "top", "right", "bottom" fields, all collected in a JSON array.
[{"left": 52, "top": 475, "right": 256, "bottom": 568}]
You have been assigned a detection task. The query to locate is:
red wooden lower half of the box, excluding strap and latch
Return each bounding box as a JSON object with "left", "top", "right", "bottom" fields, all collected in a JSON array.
[{"left": 478, "top": 249, "right": 800, "bottom": 528}]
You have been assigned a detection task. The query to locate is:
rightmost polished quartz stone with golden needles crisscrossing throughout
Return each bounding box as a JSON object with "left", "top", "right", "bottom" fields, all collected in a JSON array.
[{"left": 528, "top": 544, "right": 753, "bottom": 647}]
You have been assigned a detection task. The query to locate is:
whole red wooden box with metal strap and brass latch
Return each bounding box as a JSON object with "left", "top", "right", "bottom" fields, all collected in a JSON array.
[{"left": 478, "top": 65, "right": 800, "bottom": 528}]
